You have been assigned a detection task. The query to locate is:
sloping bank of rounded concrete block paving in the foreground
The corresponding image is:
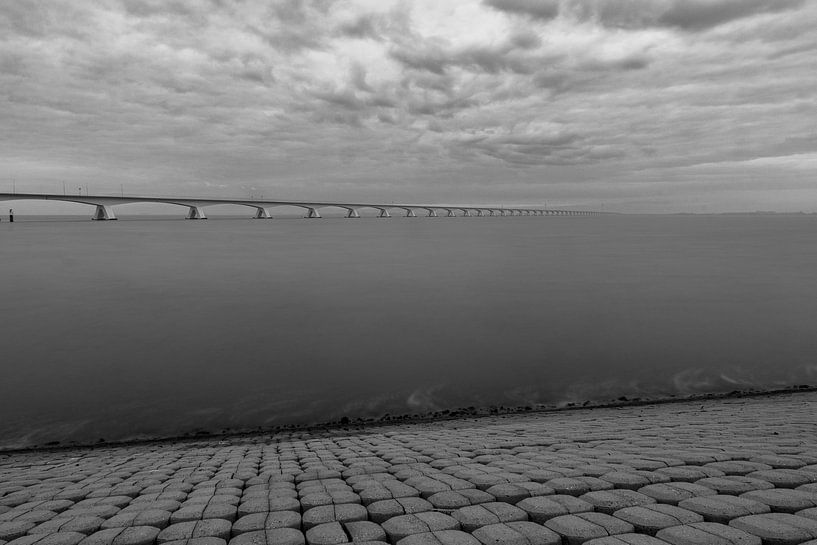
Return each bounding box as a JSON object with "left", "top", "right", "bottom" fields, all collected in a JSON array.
[{"left": 0, "top": 392, "right": 817, "bottom": 545}]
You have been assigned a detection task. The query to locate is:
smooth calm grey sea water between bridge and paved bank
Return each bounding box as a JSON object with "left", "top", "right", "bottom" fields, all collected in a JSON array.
[{"left": 0, "top": 216, "right": 817, "bottom": 446}]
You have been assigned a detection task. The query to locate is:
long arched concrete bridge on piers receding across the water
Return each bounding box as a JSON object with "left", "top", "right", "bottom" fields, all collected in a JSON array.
[{"left": 0, "top": 193, "right": 604, "bottom": 217}]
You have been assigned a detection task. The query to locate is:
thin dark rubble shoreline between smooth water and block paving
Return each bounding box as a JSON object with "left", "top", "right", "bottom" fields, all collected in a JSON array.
[{"left": 0, "top": 384, "right": 817, "bottom": 457}]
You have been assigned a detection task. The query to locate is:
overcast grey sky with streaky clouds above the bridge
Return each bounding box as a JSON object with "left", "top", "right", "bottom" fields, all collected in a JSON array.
[{"left": 0, "top": 0, "right": 817, "bottom": 212}]
